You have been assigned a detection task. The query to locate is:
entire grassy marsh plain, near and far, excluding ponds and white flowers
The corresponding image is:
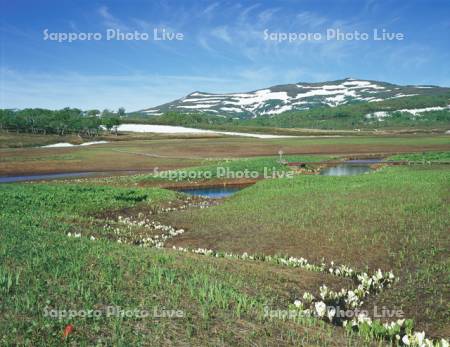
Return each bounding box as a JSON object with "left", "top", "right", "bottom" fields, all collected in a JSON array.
[{"left": 0, "top": 136, "right": 450, "bottom": 346}]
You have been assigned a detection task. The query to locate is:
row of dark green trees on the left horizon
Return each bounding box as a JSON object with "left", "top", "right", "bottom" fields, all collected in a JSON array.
[{"left": 0, "top": 107, "right": 125, "bottom": 136}]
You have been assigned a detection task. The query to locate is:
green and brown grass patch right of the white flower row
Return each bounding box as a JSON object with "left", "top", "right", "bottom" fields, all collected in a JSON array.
[{"left": 162, "top": 166, "right": 450, "bottom": 336}]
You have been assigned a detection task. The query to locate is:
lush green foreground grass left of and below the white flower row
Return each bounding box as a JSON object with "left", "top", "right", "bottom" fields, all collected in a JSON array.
[{"left": 0, "top": 184, "right": 365, "bottom": 346}]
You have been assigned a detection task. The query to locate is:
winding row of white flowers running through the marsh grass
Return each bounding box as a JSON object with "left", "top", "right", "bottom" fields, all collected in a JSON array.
[{"left": 75, "top": 215, "right": 449, "bottom": 347}]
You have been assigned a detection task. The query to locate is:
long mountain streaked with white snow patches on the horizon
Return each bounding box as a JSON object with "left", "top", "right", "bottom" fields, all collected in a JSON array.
[{"left": 140, "top": 78, "right": 450, "bottom": 118}]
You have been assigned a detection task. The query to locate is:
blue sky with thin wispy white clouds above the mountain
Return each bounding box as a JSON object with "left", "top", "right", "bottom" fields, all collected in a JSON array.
[{"left": 0, "top": 0, "right": 450, "bottom": 111}]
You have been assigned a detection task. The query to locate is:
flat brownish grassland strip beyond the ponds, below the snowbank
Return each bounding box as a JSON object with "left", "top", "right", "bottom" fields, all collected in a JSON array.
[{"left": 0, "top": 135, "right": 450, "bottom": 175}]
